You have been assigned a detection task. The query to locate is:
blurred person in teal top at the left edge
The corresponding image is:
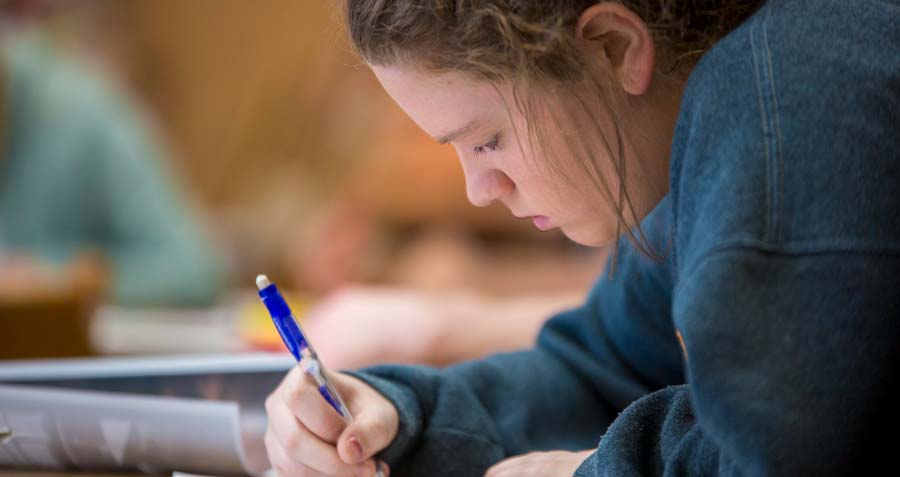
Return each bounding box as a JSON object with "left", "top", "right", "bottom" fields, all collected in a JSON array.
[{"left": 0, "top": 23, "right": 223, "bottom": 306}]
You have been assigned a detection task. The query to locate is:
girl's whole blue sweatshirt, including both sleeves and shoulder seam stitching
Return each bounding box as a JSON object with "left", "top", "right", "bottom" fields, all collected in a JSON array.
[{"left": 350, "top": 0, "right": 900, "bottom": 477}]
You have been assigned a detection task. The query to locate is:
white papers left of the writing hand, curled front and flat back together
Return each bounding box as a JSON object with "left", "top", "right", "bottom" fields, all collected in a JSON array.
[{"left": 0, "top": 354, "right": 293, "bottom": 476}]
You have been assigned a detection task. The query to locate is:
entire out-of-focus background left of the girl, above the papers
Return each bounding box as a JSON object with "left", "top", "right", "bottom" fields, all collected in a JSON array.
[{"left": 0, "top": 0, "right": 605, "bottom": 368}]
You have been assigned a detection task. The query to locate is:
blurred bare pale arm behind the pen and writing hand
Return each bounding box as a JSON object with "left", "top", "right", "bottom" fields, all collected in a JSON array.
[{"left": 303, "top": 286, "right": 579, "bottom": 369}]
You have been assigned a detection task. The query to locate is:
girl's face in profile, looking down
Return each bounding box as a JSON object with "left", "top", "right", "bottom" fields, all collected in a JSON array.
[{"left": 372, "top": 66, "right": 671, "bottom": 246}]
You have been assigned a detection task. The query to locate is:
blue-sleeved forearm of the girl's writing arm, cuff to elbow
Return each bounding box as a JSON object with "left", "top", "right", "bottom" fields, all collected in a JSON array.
[{"left": 358, "top": 349, "right": 615, "bottom": 477}]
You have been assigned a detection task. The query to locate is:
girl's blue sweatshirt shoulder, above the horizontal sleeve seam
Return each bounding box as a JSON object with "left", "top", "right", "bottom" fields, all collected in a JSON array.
[{"left": 671, "top": 0, "right": 900, "bottom": 274}]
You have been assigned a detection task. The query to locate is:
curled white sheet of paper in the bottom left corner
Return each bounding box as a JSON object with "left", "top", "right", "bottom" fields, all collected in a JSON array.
[{"left": 0, "top": 385, "right": 268, "bottom": 475}]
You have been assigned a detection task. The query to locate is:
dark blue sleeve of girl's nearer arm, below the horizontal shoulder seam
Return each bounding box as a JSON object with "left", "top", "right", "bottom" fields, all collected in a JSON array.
[{"left": 576, "top": 246, "right": 900, "bottom": 477}]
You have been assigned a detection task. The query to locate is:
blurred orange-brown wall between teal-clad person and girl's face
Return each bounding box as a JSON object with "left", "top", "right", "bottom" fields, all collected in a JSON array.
[{"left": 90, "top": 0, "right": 522, "bottom": 278}]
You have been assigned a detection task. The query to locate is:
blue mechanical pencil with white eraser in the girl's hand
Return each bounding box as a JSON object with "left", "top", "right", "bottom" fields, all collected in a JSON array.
[{"left": 256, "top": 275, "right": 384, "bottom": 477}]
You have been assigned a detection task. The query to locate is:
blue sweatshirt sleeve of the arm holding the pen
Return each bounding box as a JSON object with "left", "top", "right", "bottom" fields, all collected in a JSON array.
[{"left": 348, "top": 199, "right": 683, "bottom": 476}]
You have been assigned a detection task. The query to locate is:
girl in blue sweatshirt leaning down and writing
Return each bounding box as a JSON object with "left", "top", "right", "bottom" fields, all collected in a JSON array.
[{"left": 267, "top": 0, "right": 900, "bottom": 477}]
